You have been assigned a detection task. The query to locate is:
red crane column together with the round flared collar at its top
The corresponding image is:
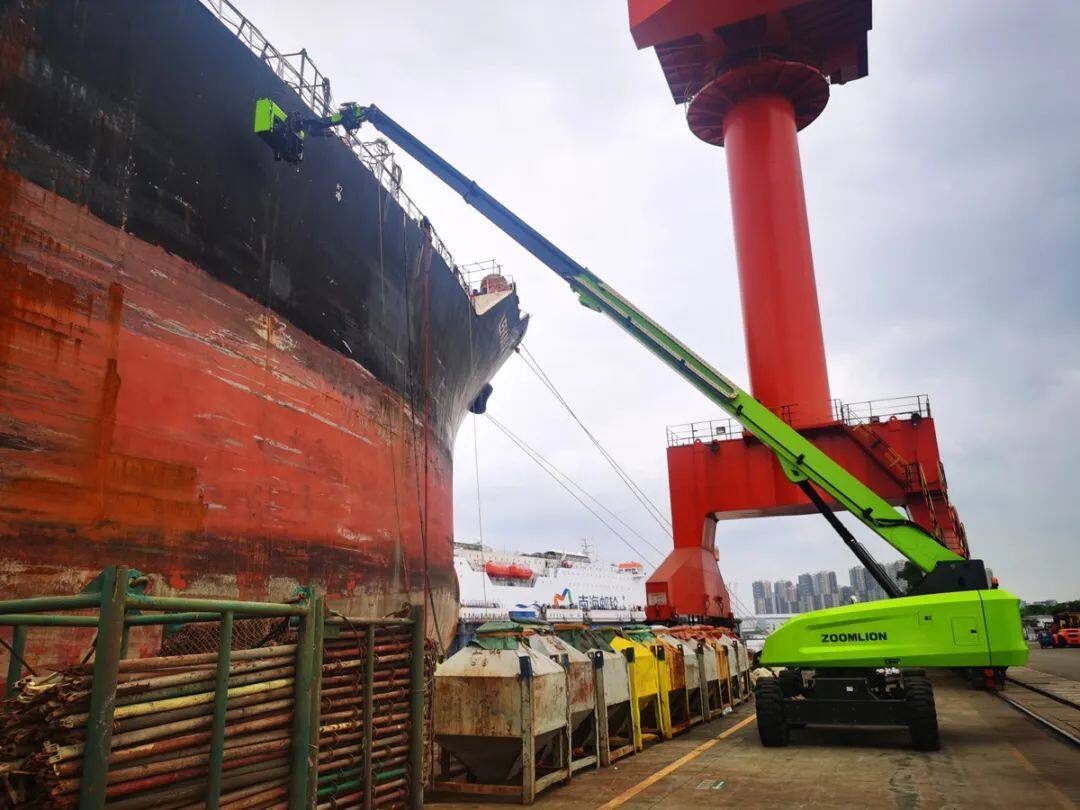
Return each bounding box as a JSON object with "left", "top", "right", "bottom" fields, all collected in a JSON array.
[{"left": 687, "top": 54, "right": 832, "bottom": 428}]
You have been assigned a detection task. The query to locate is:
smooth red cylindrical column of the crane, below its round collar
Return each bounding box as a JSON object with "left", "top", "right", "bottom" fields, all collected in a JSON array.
[{"left": 724, "top": 93, "right": 831, "bottom": 426}]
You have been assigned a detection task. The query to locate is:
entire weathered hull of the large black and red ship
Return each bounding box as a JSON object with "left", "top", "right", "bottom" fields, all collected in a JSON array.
[{"left": 0, "top": 0, "right": 526, "bottom": 663}]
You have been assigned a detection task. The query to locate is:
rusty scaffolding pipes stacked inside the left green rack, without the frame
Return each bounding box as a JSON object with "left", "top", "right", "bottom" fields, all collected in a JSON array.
[{"left": 0, "top": 645, "right": 296, "bottom": 810}]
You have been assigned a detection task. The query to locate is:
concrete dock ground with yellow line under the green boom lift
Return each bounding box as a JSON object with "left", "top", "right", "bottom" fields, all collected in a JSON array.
[{"left": 434, "top": 673, "right": 1080, "bottom": 810}]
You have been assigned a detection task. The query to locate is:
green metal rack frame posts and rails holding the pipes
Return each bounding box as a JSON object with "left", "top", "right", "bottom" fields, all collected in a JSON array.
[{"left": 0, "top": 566, "right": 424, "bottom": 810}]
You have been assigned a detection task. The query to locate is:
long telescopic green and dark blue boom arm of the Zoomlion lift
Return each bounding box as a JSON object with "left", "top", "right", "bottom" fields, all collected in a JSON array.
[{"left": 361, "top": 105, "right": 961, "bottom": 572}]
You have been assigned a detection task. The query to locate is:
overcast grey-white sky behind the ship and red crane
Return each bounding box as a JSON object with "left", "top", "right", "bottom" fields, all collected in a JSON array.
[{"left": 238, "top": 0, "right": 1080, "bottom": 606}]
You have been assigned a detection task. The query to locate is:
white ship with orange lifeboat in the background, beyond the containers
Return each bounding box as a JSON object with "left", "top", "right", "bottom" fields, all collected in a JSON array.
[{"left": 454, "top": 542, "right": 646, "bottom": 623}]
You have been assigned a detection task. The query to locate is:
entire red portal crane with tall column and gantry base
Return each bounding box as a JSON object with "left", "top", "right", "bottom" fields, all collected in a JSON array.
[{"left": 629, "top": 0, "right": 968, "bottom": 621}]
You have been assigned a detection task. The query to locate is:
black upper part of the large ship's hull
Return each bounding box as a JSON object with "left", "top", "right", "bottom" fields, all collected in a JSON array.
[{"left": 0, "top": 0, "right": 526, "bottom": 449}]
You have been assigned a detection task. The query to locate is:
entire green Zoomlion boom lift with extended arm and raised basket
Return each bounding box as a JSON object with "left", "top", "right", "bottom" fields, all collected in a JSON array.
[{"left": 256, "top": 99, "right": 1027, "bottom": 748}]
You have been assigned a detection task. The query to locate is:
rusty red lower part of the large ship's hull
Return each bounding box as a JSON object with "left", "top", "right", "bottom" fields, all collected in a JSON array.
[{"left": 0, "top": 174, "right": 456, "bottom": 639}]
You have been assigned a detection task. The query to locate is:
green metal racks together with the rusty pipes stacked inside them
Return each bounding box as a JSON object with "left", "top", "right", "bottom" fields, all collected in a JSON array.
[{"left": 0, "top": 567, "right": 433, "bottom": 810}]
